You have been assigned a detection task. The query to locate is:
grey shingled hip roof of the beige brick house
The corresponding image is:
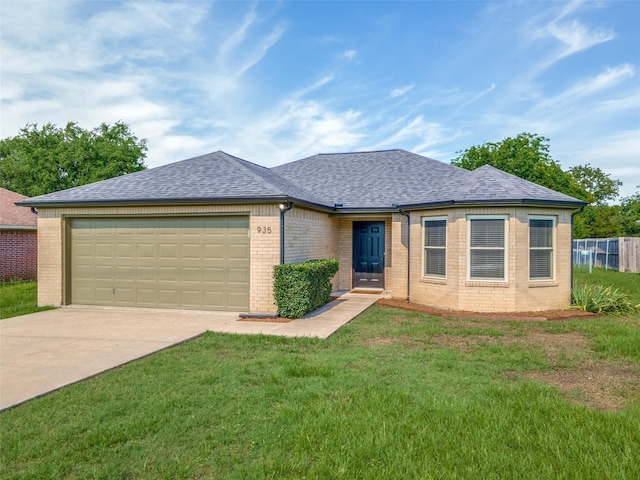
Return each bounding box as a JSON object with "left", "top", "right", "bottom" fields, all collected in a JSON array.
[{"left": 17, "top": 150, "right": 585, "bottom": 211}]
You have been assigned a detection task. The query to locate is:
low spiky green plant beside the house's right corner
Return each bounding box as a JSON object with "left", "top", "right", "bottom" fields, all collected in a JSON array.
[{"left": 571, "top": 284, "right": 640, "bottom": 315}]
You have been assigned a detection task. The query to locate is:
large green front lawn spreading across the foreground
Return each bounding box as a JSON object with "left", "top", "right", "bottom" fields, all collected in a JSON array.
[{"left": 0, "top": 306, "right": 640, "bottom": 479}]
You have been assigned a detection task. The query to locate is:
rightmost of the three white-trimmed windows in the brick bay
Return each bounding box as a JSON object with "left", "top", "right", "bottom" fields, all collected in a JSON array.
[{"left": 529, "top": 215, "right": 556, "bottom": 280}]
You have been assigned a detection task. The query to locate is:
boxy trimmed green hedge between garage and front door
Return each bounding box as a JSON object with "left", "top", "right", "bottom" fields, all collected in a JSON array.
[{"left": 273, "top": 259, "right": 339, "bottom": 318}]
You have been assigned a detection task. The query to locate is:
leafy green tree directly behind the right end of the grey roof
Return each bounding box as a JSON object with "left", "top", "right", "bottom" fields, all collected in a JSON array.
[{"left": 451, "top": 132, "right": 592, "bottom": 202}]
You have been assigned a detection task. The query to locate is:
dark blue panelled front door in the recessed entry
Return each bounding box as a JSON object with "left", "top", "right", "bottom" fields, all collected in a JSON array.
[{"left": 352, "top": 222, "right": 384, "bottom": 288}]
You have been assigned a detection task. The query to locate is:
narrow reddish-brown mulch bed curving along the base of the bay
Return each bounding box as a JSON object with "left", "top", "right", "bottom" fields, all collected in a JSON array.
[{"left": 376, "top": 298, "right": 598, "bottom": 321}]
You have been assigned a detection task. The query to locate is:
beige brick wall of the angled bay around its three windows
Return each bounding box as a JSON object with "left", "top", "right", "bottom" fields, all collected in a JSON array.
[{"left": 400, "top": 207, "right": 571, "bottom": 312}]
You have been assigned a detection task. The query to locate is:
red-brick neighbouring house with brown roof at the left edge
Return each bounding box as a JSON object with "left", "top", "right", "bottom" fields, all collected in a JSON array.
[{"left": 0, "top": 188, "right": 38, "bottom": 282}]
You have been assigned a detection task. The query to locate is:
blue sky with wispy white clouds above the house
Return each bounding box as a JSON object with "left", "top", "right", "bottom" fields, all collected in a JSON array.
[{"left": 0, "top": 0, "right": 640, "bottom": 195}]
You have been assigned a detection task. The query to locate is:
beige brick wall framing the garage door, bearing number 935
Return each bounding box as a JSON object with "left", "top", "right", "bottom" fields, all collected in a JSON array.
[{"left": 38, "top": 205, "right": 280, "bottom": 313}]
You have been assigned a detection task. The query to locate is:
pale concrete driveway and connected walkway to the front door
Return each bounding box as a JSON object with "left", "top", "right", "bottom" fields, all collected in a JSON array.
[{"left": 0, "top": 293, "right": 380, "bottom": 410}]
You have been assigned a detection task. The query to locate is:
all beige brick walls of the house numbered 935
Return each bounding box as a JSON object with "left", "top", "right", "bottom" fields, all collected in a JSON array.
[{"left": 38, "top": 205, "right": 571, "bottom": 313}]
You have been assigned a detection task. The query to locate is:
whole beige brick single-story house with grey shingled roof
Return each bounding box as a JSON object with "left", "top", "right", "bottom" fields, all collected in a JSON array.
[{"left": 20, "top": 150, "right": 585, "bottom": 313}]
